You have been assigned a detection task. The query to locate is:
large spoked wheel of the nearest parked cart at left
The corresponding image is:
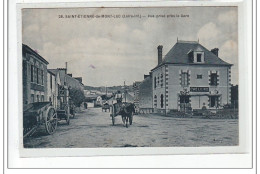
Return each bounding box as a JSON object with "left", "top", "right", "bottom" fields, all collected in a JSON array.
[{"left": 45, "top": 107, "right": 58, "bottom": 135}]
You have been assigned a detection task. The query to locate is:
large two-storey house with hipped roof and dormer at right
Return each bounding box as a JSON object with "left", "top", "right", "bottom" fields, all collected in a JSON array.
[{"left": 151, "top": 41, "right": 232, "bottom": 113}]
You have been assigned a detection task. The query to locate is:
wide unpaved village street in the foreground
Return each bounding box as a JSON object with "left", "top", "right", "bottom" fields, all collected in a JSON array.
[{"left": 24, "top": 108, "right": 238, "bottom": 148}]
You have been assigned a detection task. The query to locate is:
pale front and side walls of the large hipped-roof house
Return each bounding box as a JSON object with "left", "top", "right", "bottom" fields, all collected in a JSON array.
[{"left": 152, "top": 65, "right": 231, "bottom": 111}]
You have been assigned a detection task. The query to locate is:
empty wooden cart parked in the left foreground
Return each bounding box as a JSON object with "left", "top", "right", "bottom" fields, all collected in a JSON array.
[{"left": 23, "top": 102, "right": 57, "bottom": 138}]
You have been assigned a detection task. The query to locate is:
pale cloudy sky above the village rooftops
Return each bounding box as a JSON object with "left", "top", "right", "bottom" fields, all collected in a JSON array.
[{"left": 22, "top": 7, "right": 238, "bottom": 86}]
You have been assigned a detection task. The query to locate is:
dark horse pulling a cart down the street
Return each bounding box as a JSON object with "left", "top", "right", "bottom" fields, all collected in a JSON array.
[{"left": 120, "top": 103, "right": 135, "bottom": 127}]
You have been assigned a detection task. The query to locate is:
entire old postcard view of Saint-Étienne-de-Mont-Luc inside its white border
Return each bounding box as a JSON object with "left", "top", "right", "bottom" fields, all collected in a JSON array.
[{"left": 19, "top": 6, "right": 240, "bottom": 149}]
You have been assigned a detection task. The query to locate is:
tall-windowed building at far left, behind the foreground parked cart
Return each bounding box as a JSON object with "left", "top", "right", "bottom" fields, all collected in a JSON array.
[{"left": 22, "top": 44, "right": 49, "bottom": 104}]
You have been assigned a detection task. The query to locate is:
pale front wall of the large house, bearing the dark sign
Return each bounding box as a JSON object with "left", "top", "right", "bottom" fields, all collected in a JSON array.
[{"left": 168, "top": 65, "right": 231, "bottom": 109}]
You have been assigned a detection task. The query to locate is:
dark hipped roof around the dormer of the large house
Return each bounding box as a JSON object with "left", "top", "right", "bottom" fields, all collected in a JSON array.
[{"left": 154, "top": 41, "right": 232, "bottom": 69}]
